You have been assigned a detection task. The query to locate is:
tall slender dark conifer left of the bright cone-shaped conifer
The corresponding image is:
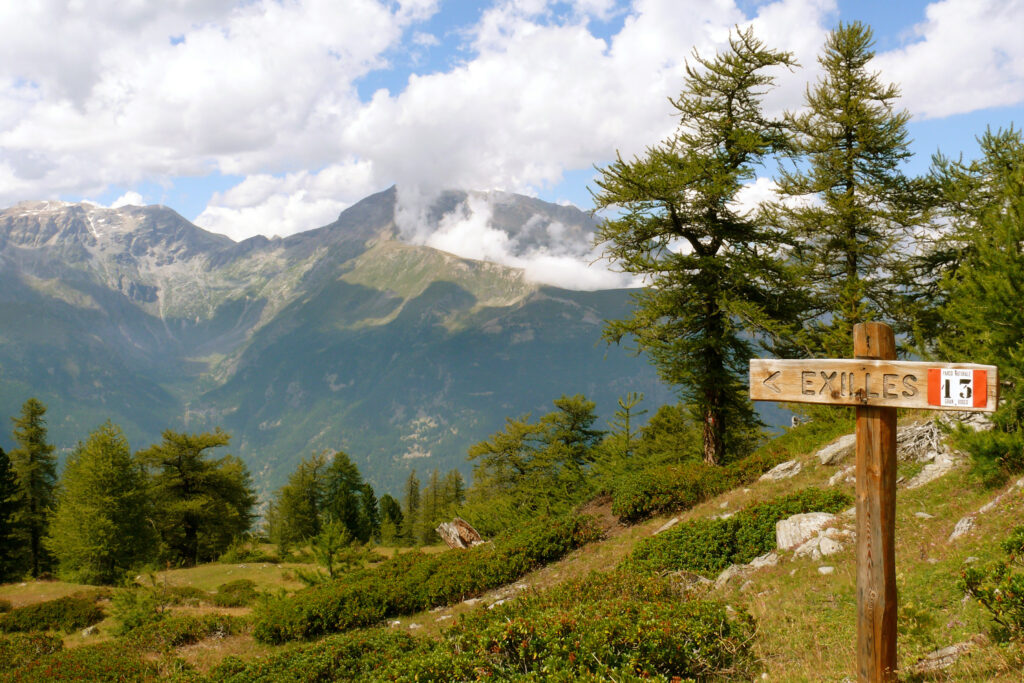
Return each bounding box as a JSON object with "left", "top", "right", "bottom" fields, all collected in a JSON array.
[{"left": 9, "top": 398, "right": 57, "bottom": 577}]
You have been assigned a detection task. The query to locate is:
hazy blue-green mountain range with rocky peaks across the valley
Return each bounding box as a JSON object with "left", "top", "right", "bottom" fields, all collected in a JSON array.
[{"left": 0, "top": 187, "right": 672, "bottom": 494}]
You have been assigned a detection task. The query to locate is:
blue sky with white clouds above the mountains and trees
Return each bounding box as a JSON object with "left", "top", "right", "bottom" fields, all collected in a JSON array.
[{"left": 0, "top": 0, "right": 1024, "bottom": 282}]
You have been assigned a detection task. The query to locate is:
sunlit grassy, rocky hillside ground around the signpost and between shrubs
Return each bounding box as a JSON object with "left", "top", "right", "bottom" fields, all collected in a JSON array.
[{"left": 0, "top": 416, "right": 1024, "bottom": 683}]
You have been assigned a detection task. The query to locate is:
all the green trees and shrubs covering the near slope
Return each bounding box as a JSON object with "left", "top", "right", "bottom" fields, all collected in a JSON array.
[{"left": 0, "top": 23, "right": 1024, "bottom": 681}]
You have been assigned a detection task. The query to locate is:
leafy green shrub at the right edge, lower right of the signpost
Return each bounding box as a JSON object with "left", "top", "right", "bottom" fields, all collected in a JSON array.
[{"left": 958, "top": 526, "right": 1024, "bottom": 642}]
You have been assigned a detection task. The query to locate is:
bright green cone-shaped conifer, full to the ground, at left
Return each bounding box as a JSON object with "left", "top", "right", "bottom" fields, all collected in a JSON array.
[{"left": 45, "top": 422, "right": 157, "bottom": 584}]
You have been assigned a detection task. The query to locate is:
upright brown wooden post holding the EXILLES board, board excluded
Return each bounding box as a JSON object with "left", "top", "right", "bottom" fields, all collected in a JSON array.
[{"left": 853, "top": 323, "right": 896, "bottom": 683}]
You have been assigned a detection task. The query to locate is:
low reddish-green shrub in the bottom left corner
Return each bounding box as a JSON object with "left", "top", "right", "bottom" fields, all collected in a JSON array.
[{"left": 4, "top": 641, "right": 158, "bottom": 683}]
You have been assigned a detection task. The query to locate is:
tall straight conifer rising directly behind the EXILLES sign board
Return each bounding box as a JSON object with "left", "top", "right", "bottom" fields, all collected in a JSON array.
[{"left": 768, "top": 22, "right": 924, "bottom": 358}]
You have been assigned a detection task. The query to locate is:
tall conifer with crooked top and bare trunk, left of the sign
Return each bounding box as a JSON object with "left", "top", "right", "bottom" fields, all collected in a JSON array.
[{"left": 594, "top": 26, "right": 803, "bottom": 464}]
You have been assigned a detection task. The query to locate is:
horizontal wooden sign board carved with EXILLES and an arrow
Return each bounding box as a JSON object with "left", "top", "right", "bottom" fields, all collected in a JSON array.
[{"left": 750, "top": 358, "right": 999, "bottom": 413}]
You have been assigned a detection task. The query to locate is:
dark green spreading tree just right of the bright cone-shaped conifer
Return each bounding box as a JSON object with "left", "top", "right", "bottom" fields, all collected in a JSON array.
[{"left": 137, "top": 429, "right": 256, "bottom": 566}]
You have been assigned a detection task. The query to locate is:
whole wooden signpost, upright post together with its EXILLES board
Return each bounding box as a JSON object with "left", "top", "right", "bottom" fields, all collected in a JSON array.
[{"left": 751, "top": 323, "right": 999, "bottom": 683}]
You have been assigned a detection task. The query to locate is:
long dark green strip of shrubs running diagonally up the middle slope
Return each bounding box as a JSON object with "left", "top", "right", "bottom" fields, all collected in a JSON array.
[{"left": 253, "top": 516, "right": 600, "bottom": 643}]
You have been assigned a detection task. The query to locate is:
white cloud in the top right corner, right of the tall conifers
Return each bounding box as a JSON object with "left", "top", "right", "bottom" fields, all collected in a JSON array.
[{"left": 876, "top": 0, "right": 1024, "bottom": 119}]
